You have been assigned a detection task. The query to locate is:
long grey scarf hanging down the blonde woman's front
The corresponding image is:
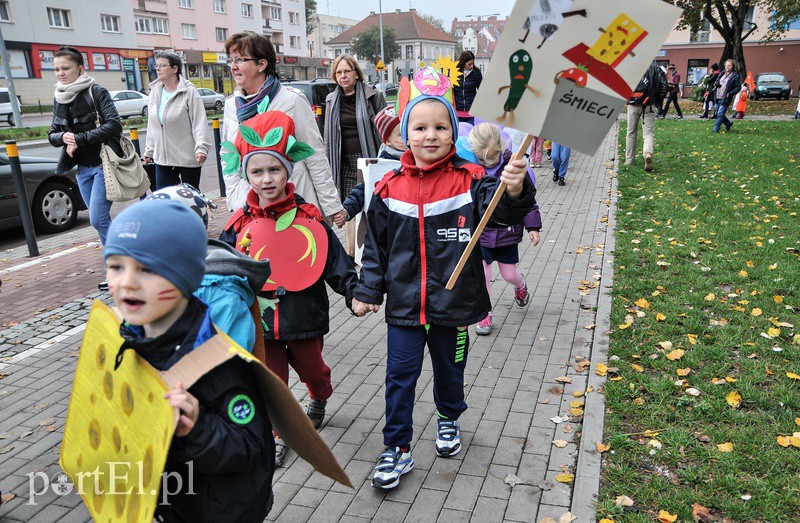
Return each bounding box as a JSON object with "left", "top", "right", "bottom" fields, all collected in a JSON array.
[{"left": 325, "top": 80, "right": 379, "bottom": 188}]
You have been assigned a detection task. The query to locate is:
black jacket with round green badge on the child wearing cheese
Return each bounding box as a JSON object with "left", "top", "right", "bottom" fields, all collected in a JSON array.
[{"left": 118, "top": 297, "right": 275, "bottom": 523}]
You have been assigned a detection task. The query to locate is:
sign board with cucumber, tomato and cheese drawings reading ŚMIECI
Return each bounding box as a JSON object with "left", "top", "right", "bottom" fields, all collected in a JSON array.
[{"left": 470, "top": 0, "right": 681, "bottom": 154}]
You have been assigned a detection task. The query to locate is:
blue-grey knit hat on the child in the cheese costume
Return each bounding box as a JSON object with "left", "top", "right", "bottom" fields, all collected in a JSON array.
[{"left": 103, "top": 200, "right": 208, "bottom": 298}]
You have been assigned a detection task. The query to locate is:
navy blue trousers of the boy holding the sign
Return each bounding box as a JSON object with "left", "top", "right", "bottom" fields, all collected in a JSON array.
[{"left": 383, "top": 325, "right": 469, "bottom": 447}]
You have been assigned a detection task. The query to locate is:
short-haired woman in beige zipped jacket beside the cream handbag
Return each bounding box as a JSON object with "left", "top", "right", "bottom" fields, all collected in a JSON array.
[{"left": 142, "top": 51, "right": 211, "bottom": 189}]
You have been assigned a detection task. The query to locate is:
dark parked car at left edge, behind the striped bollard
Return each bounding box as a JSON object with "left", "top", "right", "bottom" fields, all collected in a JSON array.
[{"left": 0, "top": 154, "right": 86, "bottom": 234}]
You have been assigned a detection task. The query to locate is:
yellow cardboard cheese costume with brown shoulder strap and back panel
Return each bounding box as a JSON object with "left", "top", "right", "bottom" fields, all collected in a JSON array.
[{"left": 59, "top": 301, "right": 352, "bottom": 522}]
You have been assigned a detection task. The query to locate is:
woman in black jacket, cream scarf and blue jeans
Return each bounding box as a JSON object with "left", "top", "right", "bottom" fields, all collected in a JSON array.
[{"left": 48, "top": 46, "right": 122, "bottom": 245}]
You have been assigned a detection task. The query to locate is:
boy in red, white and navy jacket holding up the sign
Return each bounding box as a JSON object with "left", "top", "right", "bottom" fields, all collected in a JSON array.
[{"left": 353, "top": 86, "right": 536, "bottom": 489}]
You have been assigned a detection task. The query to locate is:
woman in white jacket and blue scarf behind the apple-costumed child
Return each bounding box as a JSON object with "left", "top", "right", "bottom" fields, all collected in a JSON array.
[{"left": 223, "top": 31, "right": 345, "bottom": 222}]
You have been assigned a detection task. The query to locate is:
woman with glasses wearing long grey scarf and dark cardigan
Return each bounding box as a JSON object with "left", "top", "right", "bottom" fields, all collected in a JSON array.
[{"left": 325, "top": 55, "right": 386, "bottom": 256}]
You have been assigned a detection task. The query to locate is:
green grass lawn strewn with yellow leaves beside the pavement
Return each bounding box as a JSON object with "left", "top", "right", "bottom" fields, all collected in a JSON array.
[{"left": 597, "top": 119, "right": 800, "bottom": 523}]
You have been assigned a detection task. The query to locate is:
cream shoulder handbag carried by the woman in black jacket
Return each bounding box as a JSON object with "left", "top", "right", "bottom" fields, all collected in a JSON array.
[{"left": 89, "top": 87, "right": 150, "bottom": 202}]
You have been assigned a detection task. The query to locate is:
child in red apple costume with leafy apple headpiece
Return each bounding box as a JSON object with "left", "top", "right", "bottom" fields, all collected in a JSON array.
[{"left": 220, "top": 104, "right": 357, "bottom": 466}]
